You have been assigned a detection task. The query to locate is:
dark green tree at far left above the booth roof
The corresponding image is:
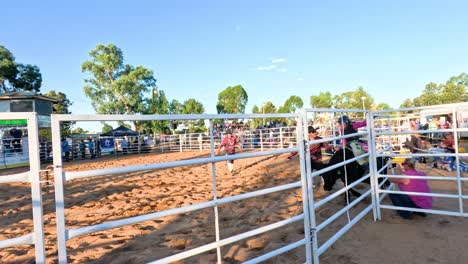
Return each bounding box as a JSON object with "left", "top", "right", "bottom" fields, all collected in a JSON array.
[{"left": 0, "top": 45, "right": 42, "bottom": 93}]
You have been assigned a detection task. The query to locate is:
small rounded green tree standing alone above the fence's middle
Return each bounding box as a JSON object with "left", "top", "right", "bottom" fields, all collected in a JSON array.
[{"left": 216, "top": 85, "right": 249, "bottom": 114}]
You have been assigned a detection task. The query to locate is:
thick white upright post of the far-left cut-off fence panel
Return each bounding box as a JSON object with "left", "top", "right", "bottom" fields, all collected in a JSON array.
[{"left": 28, "top": 113, "right": 46, "bottom": 263}]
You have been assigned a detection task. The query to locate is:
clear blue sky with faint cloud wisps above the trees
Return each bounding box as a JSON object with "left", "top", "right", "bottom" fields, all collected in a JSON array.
[{"left": 0, "top": 0, "right": 468, "bottom": 131}]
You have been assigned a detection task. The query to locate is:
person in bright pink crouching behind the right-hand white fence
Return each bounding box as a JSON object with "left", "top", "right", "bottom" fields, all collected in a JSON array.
[{"left": 389, "top": 158, "right": 432, "bottom": 219}]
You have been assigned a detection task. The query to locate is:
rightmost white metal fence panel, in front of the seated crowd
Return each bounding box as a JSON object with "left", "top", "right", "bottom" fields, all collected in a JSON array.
[{"left": 371, "top": 103, "right": 468, "bottom": 219}]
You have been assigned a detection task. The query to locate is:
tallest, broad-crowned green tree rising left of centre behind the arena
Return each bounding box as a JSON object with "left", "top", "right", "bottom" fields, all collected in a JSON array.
[{"left": 81, "top": 44, "right": 156, "bottom": 130}]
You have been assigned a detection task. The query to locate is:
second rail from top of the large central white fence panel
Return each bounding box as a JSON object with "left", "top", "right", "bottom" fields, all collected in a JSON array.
[{"left": 64, "top": 148, "right": 298, "bottom": 181}]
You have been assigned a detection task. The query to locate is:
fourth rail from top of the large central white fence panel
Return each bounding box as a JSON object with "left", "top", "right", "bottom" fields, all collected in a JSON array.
[{"left": 150, "top": 214, "right": 304, "bottom": 264}]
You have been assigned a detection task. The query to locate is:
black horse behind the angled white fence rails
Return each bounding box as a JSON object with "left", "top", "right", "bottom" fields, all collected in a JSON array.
[{"left": 322, "top": 148, "right": 389, "bottom": 202}]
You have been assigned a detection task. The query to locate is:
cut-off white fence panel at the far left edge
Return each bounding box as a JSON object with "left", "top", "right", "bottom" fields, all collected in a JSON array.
[{"left": 0, "top": 113, "right": 45, "bottom": 263}]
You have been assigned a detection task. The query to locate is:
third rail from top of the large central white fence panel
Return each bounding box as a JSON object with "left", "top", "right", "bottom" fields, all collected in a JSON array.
[{"left": 68, "top": 182, "right": 301, "bottom": 239}]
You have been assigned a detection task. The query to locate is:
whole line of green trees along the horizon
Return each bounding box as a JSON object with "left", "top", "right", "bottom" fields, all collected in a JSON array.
[{"left": 0, "top": 44, "right": 468, "bottom": 133}]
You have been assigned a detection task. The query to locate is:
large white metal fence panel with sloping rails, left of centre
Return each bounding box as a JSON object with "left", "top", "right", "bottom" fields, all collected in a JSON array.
[{"left": 51, "top": 114, "right": 312, "bottom": 263}]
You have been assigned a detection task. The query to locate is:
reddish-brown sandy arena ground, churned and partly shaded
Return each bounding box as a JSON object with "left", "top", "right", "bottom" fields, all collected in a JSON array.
[{"left": 0, "top": 152, "right": 468, "bottom": 264}]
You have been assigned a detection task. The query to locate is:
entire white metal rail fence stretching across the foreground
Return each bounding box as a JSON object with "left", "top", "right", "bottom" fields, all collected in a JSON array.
[{"left": 4, "top": 103, "right": 468, "bottom": 263}]
